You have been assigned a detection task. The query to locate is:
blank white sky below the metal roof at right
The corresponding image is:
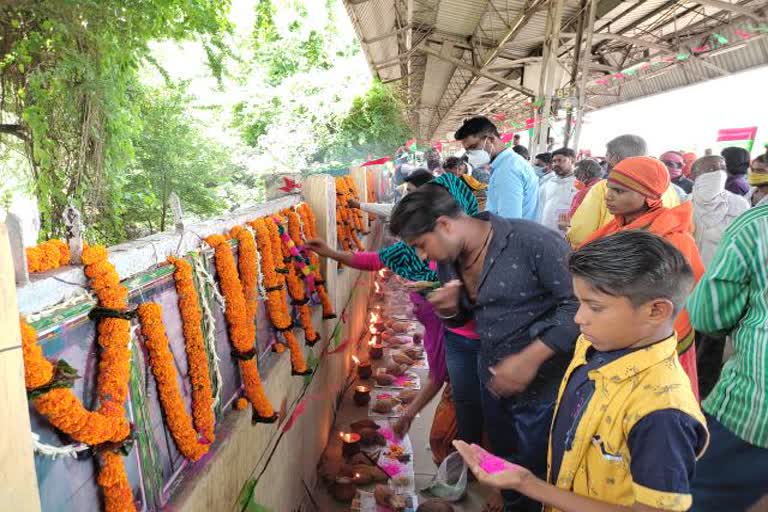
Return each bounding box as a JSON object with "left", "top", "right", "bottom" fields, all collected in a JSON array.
[{"left": 580, "top": 66, "right": 768, "bottom": 156}]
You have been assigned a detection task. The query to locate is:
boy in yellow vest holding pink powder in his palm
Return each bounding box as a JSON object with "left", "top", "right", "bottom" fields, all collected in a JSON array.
[{"left": 454, "top": 231, "right": 709, "bottom": 512}]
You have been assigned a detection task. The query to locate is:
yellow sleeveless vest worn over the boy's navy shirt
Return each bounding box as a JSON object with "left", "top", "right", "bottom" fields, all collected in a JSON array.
[{"left": 545, "top": 336, "right": 706, "bottom": 511}]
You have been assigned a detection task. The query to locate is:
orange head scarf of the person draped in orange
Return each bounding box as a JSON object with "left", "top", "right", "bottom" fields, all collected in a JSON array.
[{"left": 608, "top": 156, "right": 669, "bottom": 209}]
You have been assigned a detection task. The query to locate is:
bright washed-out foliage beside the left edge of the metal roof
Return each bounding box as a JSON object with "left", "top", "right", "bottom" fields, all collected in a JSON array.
[{"left": 233, "top": 0, "right": 411, "bottom": 169}]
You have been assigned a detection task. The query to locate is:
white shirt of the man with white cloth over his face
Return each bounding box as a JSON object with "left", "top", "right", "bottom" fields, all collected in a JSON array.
[{"left": 691, "top": 171, "right": 749, "bottom": 267}]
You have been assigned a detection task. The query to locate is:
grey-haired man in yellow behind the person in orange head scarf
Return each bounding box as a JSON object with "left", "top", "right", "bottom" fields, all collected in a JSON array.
[{"left": 566, "top": 135, "right": 680, "bottom": 247}]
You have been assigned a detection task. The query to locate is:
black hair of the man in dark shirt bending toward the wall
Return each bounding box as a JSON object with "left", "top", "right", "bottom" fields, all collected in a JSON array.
[{"left": 389, "top": 183, "right": 463, "bottom": 240}]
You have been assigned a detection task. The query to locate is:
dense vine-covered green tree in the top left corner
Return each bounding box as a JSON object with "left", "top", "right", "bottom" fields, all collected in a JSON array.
[{"left": 0, "top": 0, "right": 229, "bottom": 242}]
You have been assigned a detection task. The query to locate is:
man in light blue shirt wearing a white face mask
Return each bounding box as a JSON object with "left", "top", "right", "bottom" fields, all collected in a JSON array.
[{"left": 454, "top": 116, "right": 539, "bottom": 220}]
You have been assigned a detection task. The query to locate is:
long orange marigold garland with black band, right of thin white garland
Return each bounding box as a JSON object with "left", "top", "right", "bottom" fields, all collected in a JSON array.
[{"left": 205, "top": 235, "right": 277, "bottom": 422}]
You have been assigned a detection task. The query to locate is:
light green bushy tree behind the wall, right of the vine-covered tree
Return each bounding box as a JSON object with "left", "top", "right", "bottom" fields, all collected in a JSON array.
[{"left": 122, "top": 87, "right": 232, "bottom": 235}]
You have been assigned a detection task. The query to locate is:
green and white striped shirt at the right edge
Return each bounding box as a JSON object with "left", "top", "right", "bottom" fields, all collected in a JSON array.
[{"left": 688, "top": 206, "right": 768, "bottom": 448}]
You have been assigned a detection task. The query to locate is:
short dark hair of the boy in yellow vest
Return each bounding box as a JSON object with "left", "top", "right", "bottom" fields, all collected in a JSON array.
[{"left": 568, "top": 230, "right": 693, "bottom": 315}]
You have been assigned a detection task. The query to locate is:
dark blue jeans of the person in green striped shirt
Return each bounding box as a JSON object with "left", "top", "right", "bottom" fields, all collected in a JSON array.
[{"left": 691, "top": 414, "right": 768, "bottom": 512}]
